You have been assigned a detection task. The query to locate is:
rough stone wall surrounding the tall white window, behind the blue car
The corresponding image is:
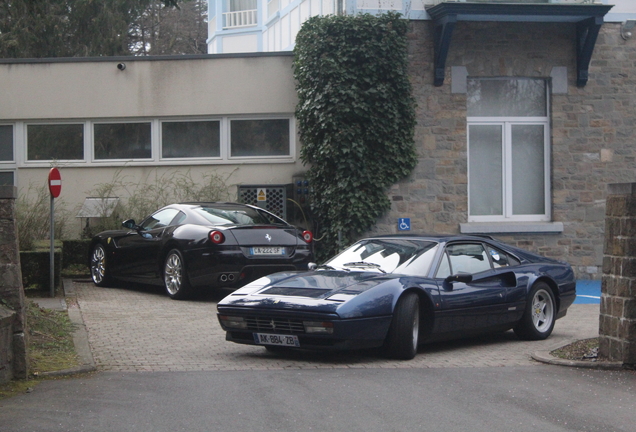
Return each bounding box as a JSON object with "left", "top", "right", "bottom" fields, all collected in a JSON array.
[{"left": 374, "top": 21, "right": 636, "bottom": 279}]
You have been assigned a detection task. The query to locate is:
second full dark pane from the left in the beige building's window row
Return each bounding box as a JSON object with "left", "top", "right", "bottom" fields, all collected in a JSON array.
[{"left": 95, "top": 123, "right": 151, "bottom": 159}]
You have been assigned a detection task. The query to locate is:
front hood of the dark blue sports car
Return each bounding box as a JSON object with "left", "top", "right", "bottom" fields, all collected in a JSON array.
[{"left": 219, "top": 270, "right": 395, "bottom": 312}]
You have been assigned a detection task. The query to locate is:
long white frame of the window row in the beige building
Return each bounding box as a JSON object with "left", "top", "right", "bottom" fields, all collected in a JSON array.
[{"left": 12, "top": 114, "right": 297, "bottom": 170}]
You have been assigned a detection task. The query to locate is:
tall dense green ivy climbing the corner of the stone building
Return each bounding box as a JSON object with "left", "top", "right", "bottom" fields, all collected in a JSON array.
[{"left": 293, "top": 13, "right": 417, "bottom": 258}]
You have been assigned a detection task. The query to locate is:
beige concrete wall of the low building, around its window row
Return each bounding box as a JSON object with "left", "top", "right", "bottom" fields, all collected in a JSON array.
[{"left": 0, "top": 53, "right": 306, "bottom": 237}]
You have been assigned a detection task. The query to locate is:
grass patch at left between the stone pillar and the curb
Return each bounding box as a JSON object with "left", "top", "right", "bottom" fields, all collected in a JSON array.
[{"left": 0, "top": 299, "right": 79, "bottom": 400}]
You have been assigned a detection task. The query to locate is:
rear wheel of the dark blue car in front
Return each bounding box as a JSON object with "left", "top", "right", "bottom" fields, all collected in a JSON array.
[{"left": 514, "top": 282, "right": 556, "bottom": 340}]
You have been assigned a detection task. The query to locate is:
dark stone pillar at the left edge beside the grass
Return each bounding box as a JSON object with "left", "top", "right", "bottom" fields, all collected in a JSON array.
[{"left": 0, "top": 186, "right": 28, "bottom": 379}]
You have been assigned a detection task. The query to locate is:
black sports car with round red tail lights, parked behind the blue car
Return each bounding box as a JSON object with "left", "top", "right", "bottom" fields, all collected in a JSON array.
[{"left": 89, "top": 203, "right": 313, "bottom": 298}]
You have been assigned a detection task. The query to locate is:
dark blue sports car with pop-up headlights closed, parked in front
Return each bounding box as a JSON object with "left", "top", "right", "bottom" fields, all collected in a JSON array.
[{"left": 218, "top": 235, "right": 576, "bottom": 359}]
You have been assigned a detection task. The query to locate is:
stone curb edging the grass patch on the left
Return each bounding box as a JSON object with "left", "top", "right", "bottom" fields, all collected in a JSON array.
[{"left": 37, "top": 279, "right": 97, "bottom": 377}]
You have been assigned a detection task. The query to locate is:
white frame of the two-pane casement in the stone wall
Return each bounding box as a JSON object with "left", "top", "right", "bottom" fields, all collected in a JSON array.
[{"left": 466, "top": 116, "right": 552, "bottom": 222}]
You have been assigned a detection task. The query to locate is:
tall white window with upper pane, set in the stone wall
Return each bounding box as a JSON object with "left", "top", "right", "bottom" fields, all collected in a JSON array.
[{"left": 467, "top": 79, "right": 550, "bottom": 222}]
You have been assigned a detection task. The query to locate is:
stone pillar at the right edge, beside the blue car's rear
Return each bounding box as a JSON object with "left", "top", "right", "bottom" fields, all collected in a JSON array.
[{"left": 599, "top": 183, "right": 636, "bottom": 367}]
